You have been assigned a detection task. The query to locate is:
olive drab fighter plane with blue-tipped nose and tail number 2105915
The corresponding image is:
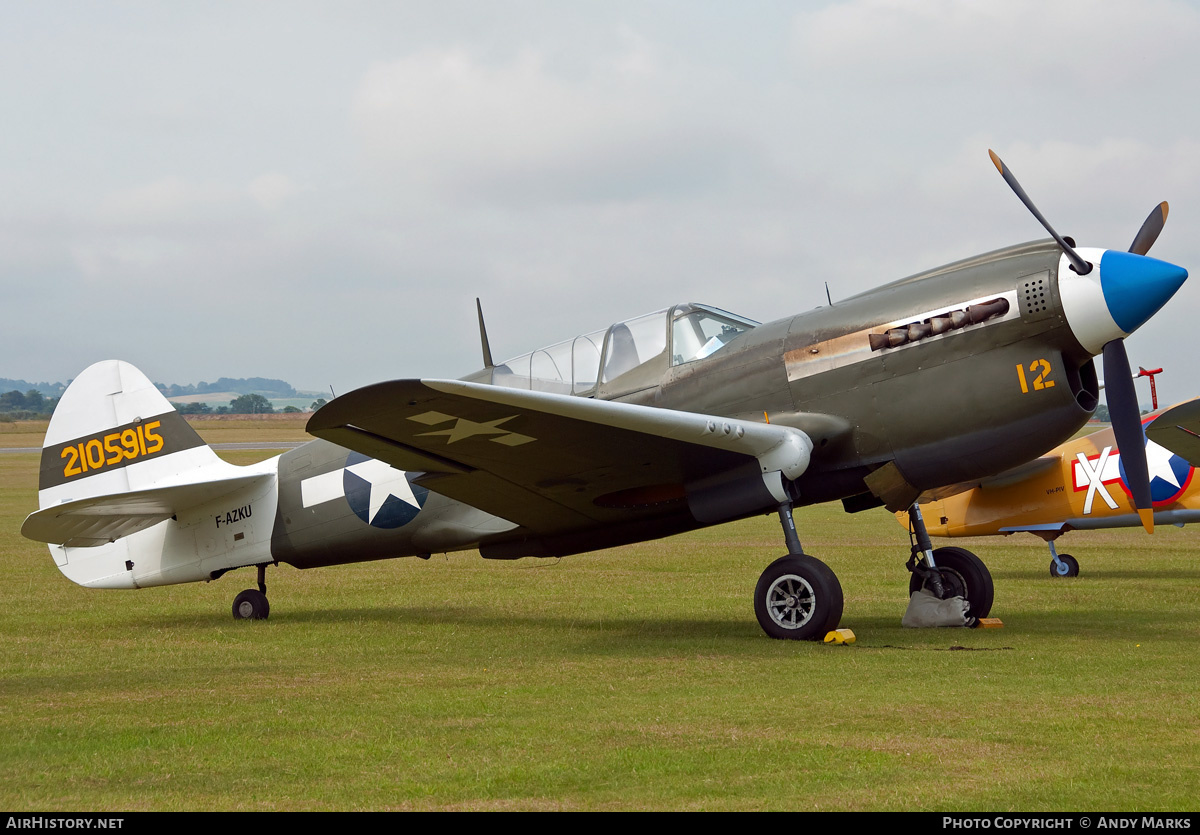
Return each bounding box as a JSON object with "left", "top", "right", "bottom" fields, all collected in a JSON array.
[{"left": 22, "top": 154, "right": 1187, "bottom": 639}]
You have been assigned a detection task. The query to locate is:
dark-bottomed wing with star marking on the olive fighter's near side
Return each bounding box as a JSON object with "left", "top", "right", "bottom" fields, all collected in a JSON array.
[{"left": 308, "top": 380, "right": 812, "bottom": 534}]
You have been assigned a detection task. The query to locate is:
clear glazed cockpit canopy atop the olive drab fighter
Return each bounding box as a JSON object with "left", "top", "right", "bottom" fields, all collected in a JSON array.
[{"left": 491, "top": 304, "right": 758, "bottom": 396}]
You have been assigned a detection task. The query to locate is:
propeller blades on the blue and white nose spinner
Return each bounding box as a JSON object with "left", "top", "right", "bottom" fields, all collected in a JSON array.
[{"left": 988, "top": 150, "right": 1168, "bottom": 533}]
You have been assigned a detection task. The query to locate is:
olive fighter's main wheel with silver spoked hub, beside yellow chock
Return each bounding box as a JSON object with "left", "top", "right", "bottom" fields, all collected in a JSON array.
[{"left": 754, "top": 555, "right": 842, "bottom": 641}]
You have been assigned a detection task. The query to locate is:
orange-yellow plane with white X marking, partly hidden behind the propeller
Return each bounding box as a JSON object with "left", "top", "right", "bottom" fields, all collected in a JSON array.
[{"left": 896, "top": 398, "right": 1200, "bottom": 577}]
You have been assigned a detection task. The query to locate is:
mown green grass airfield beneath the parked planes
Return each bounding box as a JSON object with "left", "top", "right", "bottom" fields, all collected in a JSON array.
[{"left": 0, "top": 428, "right": 1200, "bottom": 811}]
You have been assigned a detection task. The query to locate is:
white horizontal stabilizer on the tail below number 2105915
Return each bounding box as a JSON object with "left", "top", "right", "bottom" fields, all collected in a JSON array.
[{"left": 20, "top": 473, "right": 275, "bottom": 548}]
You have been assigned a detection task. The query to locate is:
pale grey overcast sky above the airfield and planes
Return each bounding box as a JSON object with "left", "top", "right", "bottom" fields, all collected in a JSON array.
[{"left": 0, "top": 0, "right": 1200, "bottom": 402}]
